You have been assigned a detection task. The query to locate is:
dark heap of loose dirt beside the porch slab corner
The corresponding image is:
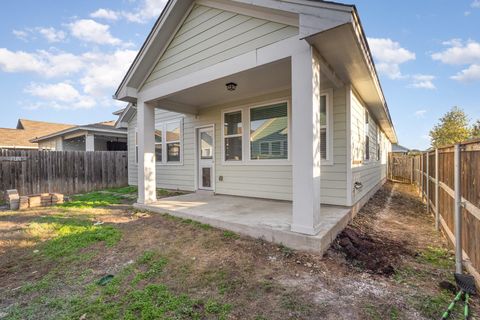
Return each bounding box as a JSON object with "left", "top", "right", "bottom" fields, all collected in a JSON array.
[{"left": 336, "top": 227, "right": 405, "bottom": 277}]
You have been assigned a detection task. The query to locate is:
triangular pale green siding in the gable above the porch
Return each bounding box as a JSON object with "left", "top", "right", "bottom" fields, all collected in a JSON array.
[{"left": 145, "top": 5, "right": 298, "bottom": 87}]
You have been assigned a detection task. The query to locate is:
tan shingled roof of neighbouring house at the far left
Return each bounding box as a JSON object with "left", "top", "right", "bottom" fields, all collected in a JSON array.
[{"left": 0, "top": 119, "right": 73, "bottom": 150}]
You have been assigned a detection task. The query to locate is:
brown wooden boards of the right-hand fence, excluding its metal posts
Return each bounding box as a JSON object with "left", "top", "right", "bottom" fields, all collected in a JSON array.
[{"left": 389, "top": 141, "right": 480, "bottom": 281}]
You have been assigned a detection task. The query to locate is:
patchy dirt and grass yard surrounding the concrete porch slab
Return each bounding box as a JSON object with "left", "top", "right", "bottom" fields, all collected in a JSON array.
[{"left": 0, "top": 184, "right": 480, "bottom": 320}]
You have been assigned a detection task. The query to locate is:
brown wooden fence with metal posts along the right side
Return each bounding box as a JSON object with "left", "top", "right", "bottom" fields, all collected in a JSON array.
[{"left": 389, "top": 140, "right": 480, "bottom": 285}]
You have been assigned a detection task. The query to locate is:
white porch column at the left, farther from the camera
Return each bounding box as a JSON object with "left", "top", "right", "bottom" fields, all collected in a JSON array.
[{"left": 137, "top": 100, "right": 157, "bottom": 204}]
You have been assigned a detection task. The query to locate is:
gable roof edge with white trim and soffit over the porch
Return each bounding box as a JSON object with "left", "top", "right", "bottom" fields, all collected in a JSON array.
[{"left": 114, "top": 0, "right": 397, "bottom": 143}]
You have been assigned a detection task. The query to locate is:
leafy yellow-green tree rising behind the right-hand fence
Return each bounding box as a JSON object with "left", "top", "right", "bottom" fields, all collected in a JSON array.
[{"left": 430, "top": 107, "right": 471, "bottom": 148}]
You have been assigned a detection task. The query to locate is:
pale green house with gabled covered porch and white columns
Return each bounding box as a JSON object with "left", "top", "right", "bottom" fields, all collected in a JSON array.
[{"left": 115, "top": 0, "right": 397, "bottom": 235}]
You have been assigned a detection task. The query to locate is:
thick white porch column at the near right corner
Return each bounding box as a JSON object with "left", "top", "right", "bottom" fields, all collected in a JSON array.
[{"left": 292, "top": 45, "right": 321, "bottom": 235}]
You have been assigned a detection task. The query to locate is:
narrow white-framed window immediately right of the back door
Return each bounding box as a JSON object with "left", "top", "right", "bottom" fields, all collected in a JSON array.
[{"left": 222, "top": 110, "right": 243, "bottom": 162}]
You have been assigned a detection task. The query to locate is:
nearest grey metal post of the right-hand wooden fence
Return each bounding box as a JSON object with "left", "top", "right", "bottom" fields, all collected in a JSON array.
[{"left": 454, "top": 144, "right": 462, "bottom": 273}]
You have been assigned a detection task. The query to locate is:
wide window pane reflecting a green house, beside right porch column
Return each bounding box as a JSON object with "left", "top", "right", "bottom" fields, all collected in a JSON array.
[{"left": 250, "top": 103, "right": 288, "bottom": 160}]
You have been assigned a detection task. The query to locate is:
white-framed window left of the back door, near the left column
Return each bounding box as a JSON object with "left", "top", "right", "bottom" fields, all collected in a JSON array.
[{"left": 155, "top": 119, "right": 183, "bottom": 164}]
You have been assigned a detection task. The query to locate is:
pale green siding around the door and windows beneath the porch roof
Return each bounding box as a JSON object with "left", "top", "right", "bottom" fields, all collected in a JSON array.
[{"left": 128, "top": 88, "right": 347, "bottom": 205}]
